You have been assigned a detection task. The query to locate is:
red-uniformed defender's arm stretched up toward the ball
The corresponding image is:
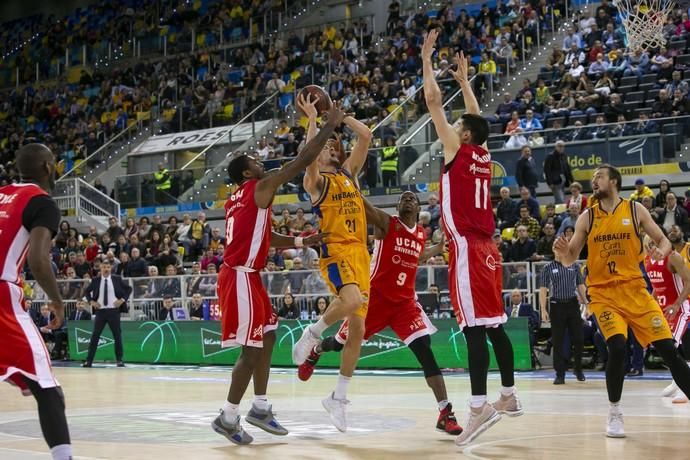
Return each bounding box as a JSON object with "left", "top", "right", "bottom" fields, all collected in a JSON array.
[{"left": 254, "top": 104, "right": 345, "bottom": 208}]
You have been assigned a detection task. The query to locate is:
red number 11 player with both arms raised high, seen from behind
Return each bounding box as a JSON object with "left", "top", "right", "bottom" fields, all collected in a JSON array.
[{"left": 422, "top": 29, "right": 522, "bottom": 446}]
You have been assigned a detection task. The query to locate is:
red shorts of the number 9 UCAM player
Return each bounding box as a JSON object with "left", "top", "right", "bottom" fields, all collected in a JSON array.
[{"left": 335, "top": 291, "right": 436, "bottom": 345}]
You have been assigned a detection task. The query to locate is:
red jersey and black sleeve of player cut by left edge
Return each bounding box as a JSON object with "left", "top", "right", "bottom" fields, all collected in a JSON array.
[{"left": 0, "top": 183, "right": 60, "bottom": 284}]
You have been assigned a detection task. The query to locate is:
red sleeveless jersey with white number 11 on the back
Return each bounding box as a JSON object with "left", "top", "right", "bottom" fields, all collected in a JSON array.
[{"left": 440, "top": 144, "right": 496, "bottom": 239}]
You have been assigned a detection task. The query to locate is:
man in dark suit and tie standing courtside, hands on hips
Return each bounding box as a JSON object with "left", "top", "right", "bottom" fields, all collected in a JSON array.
[{"left": 82, "top": 259, "right": 132, "bottom": 367}]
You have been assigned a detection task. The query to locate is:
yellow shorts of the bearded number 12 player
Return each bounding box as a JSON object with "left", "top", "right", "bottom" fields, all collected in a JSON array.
[{"left": 587, "top": 280, "right": 673, "bottom": 347}]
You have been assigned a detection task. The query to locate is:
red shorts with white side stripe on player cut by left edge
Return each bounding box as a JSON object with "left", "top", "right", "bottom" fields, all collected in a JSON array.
[{"left": 0, "top": 281, "right": 60, "bottom": 395}]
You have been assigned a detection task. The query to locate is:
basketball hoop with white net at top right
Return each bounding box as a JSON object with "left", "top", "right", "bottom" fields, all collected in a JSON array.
[{"left": 613, "top": 0, "right": 674, "bottom": 51}]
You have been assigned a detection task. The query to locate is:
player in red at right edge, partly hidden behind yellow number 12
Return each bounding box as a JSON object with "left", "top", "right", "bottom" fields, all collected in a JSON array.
[{"left": 644, "top": 234, "right": 690, "bottom": 404}]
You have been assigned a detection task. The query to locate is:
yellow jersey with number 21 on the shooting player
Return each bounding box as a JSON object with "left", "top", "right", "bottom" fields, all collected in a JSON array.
[{"left": 312, "top": 169, "right": 367, "bottom": 257}]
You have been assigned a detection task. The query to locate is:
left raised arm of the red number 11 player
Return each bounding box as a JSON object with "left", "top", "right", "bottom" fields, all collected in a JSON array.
[{"left": 422, "top": 29, "right": 460, "bottom": 164}]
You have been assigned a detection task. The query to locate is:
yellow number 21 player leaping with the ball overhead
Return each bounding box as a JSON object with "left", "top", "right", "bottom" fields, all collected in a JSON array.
[{"left": 292, "top": 93, "right": 371, "bottom": 432}]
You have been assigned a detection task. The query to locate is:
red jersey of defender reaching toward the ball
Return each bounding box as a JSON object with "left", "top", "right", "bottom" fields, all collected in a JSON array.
[{"left": 223, "top": 179, "right": 273, "bottom": 270}]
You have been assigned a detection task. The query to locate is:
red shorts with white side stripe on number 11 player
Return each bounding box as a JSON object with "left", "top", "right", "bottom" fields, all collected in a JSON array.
[{"left": 448, "top": 235, "right": 508, "bottom": 329}]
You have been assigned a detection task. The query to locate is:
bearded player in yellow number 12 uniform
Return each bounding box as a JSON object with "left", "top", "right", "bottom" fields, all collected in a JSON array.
[{"left": 553, "top": 165, "right": 690, "bottom": 438}]
